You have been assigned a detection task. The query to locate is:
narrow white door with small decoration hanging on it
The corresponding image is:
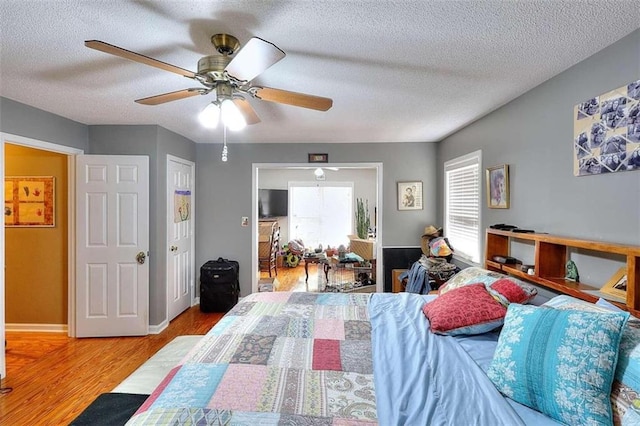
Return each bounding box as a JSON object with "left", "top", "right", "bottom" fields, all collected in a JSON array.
[{"left": 167, "top": 156, "right": 195, "bottom": 321}]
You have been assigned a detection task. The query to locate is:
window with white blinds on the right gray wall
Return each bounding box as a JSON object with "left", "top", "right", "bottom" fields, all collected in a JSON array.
[{"left": 444, "top": 151, "right": 482, "bottom": 263}]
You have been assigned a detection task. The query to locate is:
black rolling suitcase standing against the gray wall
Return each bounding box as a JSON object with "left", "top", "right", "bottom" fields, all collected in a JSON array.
[{"left": 200, "top": 257, "right": 240, "bottom": 312}]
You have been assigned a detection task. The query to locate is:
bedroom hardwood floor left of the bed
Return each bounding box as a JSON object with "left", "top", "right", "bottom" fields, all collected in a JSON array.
[{"left": 0, "top": 306, "right": 224, "bottom": 425}]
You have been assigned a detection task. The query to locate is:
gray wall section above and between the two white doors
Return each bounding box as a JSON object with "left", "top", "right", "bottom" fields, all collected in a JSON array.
[{"left": 89, "top": 125, "right": 197, "bottom": 325}]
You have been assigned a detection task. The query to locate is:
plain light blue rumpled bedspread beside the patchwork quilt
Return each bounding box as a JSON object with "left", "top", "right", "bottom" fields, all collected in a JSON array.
[{"left": 369, "top": 293, "right": 525, "bottom": 426}]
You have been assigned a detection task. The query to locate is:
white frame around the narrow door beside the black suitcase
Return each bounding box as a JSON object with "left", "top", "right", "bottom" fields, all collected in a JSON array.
[{"left": 165, "top": 154, "right": 195, "bottom": 322}]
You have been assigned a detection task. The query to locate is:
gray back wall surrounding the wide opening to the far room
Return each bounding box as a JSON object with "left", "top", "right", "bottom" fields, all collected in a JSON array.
[{"left": 196, "top": 143, "right": 437, "bottom": 295}]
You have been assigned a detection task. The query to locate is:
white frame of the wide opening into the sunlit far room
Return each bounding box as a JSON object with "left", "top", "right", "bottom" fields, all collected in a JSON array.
[{"left": 251, "top": 163, "right": 384, "bottom": 293}]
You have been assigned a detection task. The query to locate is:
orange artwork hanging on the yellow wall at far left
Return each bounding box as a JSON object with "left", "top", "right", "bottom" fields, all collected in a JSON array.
[{"left": 4, "top": 176, "right": 55, "bottom": 227}]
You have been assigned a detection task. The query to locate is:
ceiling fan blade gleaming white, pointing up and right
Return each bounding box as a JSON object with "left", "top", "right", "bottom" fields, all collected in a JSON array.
[{"left": 225, "top": 37, "right": 285, "bottom": 81}]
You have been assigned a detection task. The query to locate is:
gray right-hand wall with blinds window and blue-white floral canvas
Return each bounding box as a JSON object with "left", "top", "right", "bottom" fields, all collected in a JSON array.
[{"left": 437, "top": 30, "right": 640, "bottom": 282}]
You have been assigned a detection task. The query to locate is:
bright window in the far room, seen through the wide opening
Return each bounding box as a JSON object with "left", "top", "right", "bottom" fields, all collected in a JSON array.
[{"left": 289, "top": 182, "right": 353, "bottom": 248}]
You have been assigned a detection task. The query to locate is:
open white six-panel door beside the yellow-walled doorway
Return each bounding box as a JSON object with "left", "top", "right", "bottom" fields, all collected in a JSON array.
[{"left": 76, "top": 155, "right": 149, "bottom": 337}]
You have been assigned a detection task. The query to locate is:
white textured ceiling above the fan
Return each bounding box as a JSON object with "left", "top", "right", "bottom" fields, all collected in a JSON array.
[{"left": 0, "top": 0, "right": 640, "bottom": 143}]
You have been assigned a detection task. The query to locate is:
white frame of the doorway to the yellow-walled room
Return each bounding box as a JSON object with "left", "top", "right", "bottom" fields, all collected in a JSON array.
[{"left": 0, "top": 132, "right": 84, "bottom": 377}]
